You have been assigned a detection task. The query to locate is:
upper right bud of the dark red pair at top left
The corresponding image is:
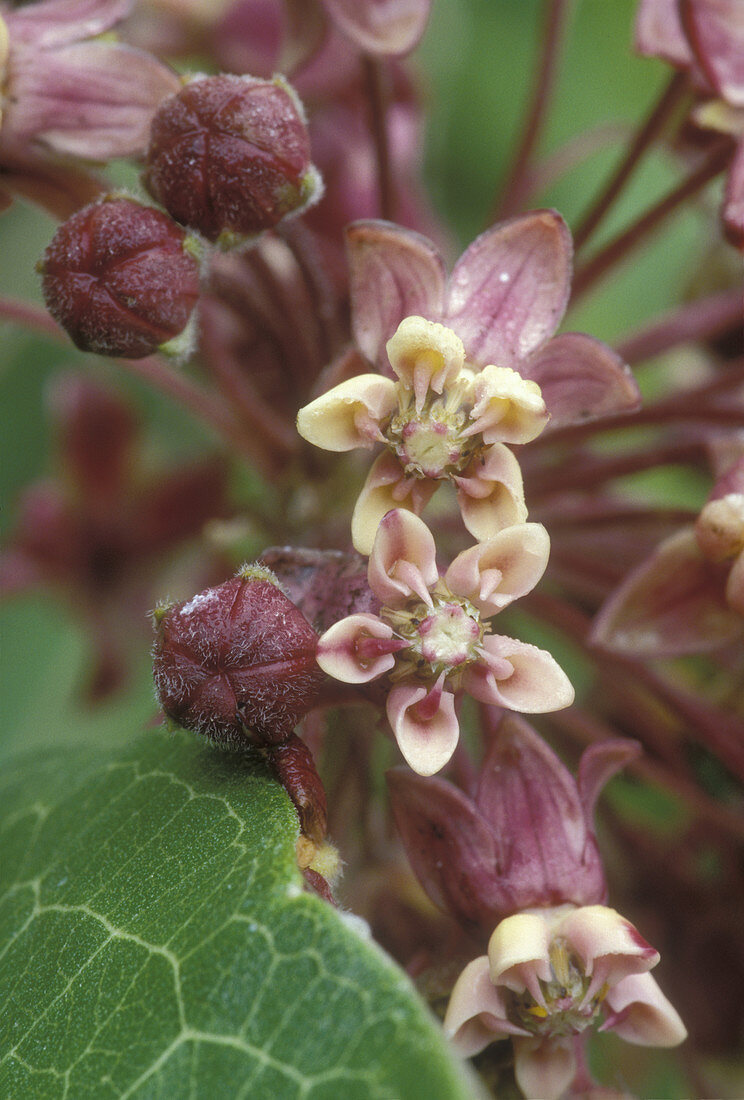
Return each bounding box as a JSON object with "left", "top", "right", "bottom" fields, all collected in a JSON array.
[{"left": 144, "top": 76, "right": 320, "bottom": 243}]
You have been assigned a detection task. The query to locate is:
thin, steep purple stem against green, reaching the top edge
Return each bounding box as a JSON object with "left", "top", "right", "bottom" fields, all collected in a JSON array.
[{"left": 490, "top": 0, "right": 569, "bottom": 222}]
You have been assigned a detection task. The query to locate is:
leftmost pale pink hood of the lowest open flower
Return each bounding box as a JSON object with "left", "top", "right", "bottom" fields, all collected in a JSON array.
[{"left": 442, "top": 955, "right": 524, "bottom": 1058}]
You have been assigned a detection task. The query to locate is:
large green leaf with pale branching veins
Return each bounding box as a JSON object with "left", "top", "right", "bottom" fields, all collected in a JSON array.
[{"left": 0, "top": 732, "right": 474, "bottom": 1100}]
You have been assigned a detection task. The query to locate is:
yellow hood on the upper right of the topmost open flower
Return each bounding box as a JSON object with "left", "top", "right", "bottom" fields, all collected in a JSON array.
[{"left": 464, "top": 365, "right": 548, "bottom": 443}]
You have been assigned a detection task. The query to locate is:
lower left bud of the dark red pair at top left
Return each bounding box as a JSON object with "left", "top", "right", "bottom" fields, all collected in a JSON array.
[{"left": 40, "top": 197, "right": 199, "bottom": 359}]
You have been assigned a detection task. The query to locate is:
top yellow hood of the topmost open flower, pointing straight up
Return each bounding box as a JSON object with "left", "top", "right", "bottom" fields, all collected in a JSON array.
[{"left": 386, "top": 317, "right": 464, "bottom": 411}]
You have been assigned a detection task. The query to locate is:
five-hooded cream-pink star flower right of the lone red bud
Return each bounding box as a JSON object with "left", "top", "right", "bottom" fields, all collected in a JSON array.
[{"left": 316, "top": 509, "right": 573, "bottom": 776}]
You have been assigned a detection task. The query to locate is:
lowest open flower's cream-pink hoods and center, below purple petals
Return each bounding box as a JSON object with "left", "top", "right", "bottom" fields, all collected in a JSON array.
[{"left": 445, "top": 905, "right": 687, "bottom": 1100}]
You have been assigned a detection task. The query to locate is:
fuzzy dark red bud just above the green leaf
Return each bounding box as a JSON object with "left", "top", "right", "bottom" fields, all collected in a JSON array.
[{"left": 153, "top": 565, "right": 324, "bottom": 745}]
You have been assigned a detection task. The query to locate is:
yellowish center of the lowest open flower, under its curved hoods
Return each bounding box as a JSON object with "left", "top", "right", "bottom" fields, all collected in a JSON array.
[{"left": 507, "top": 939, "right": 606, "bottom": 1038}]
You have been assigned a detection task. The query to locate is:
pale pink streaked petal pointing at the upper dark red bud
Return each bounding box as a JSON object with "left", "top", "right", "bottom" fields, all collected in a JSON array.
[{"left": 3, "top": 41, "right": 180, "bottom": 161}]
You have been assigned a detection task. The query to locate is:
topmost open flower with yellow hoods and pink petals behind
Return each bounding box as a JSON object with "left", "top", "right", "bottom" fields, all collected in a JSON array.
[{"left": 297, "top": 210, "right": 638, "bottom": 553}]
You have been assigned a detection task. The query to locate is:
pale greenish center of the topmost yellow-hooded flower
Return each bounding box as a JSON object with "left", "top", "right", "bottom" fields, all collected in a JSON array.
[{"left": 383, "top": 383, "right": 481, "bottom": 480}]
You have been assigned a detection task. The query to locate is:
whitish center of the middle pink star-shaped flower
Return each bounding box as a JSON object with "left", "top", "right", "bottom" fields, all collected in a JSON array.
[{"left": 381, "top": 581, "right": 488, "bottom": 683}]
